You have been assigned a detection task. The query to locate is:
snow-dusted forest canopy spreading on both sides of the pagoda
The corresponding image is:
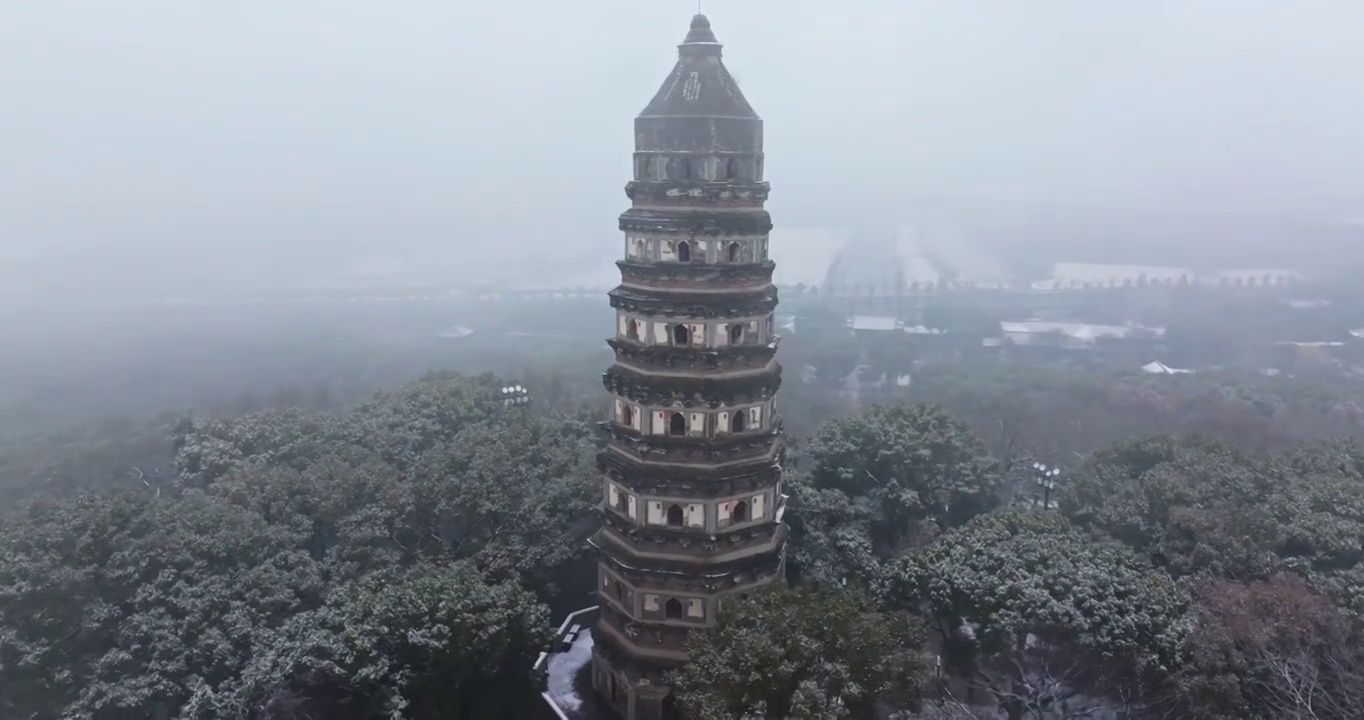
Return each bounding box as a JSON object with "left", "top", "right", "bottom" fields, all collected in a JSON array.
[{"left": 0, "top": 368, "right": 1364, "bottom": 720}]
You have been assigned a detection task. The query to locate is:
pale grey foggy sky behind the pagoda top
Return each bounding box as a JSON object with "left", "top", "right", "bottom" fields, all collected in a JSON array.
[{"left": 0, "top": 0, "right": 1364, "bottom": 292}]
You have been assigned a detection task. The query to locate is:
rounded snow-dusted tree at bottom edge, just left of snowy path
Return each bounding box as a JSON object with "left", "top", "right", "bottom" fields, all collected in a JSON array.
[{"left": 210, "top": 566, "right": 554, "bottom": 720}]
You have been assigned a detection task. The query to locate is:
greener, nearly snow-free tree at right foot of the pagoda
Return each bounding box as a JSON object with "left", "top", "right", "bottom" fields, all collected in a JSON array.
[{"left": 670, "top": 585, "right": 925, "bottom": 720}]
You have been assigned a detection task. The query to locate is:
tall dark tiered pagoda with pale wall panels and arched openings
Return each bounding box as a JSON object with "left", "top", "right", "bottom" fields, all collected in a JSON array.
[{"left": 592, "top": 15, "right": 786, "bottom": 720}]
